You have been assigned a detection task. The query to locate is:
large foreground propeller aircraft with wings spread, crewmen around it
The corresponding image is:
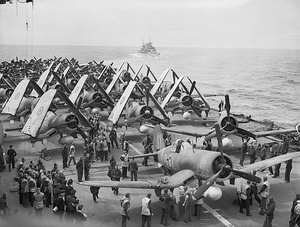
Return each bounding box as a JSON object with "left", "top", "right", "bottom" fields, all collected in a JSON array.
[{"left": 81, "top": 124, "right": 300, "bottom": 220}]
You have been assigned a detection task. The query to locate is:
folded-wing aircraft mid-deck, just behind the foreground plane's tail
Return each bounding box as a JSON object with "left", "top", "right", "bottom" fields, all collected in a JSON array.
[{"left": 108, "top": 80, "right": 169, "bottom": 127}]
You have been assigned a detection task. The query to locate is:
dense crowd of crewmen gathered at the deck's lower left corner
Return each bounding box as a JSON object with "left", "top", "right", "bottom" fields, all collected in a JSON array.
[{"left": 0, "top": 155, "right": 87, "bottom": 225}]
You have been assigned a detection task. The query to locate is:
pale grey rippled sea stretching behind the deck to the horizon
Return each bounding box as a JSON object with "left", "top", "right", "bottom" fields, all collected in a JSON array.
[{"left": 0, "top": 45, "right": 300, "bottom": 127}]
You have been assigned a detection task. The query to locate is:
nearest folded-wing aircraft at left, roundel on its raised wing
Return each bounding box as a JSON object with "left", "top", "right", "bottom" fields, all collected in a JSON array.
[{"left": 21, "top": 89, "right": 92, "bottom": 144}]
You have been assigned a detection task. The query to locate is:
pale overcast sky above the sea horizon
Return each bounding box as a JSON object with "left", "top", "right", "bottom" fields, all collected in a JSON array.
[{"left": 0, "top": 0, "right": 300, "bottom": 49}]
